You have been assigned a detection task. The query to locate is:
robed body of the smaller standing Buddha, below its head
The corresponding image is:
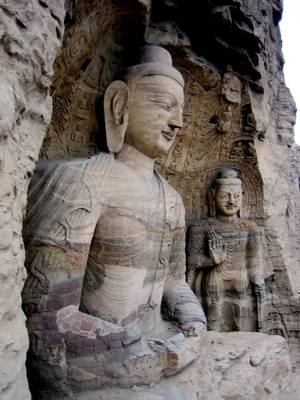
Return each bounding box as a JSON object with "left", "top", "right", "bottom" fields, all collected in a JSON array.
[{"left": 187, "top": 218, "right": 264, "bottom": 332}]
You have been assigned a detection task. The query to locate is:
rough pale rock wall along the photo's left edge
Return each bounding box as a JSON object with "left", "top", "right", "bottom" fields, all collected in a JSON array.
[{"left": 0, "top": 0, "right": 65, "bottom": 400}]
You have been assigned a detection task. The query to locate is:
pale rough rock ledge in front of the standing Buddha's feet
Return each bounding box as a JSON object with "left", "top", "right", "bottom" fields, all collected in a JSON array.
[{"left": 73, "top": 332, "right": 291, "bottom": 400}]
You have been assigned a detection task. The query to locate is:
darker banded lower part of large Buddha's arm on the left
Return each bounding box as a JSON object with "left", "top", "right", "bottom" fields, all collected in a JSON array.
[{"left": 23, "top": 239, "right": 135, "bottom": 354}]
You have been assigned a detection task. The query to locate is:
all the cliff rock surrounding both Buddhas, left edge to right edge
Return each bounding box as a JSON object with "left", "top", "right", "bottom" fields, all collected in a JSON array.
[{"left": 0, "top": 0, "right": 300, "bottom": 399}]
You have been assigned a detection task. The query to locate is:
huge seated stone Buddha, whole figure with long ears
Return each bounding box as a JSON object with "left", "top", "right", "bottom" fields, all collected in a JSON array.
[{"left": 23, "top": 46, "right": 206, "bottom": 398}]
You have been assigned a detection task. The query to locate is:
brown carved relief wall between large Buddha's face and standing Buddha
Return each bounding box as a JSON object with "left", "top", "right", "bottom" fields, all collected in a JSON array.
[{"left": 157, "top": 61, "right": 263, "bottom": 224}]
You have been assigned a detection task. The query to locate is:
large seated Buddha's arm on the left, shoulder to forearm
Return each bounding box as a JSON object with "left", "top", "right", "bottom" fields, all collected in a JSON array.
[{"left": 23, "top": 161, "right": 135, "bottom": 358}]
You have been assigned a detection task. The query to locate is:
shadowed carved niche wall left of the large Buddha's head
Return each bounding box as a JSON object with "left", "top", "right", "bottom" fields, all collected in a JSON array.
[{"left": 40, "top": 0, "right": 146, "bottom": 159}]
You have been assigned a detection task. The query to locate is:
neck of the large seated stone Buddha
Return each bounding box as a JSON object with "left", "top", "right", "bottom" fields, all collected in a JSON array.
[{"left": 116, "top": 143, "right": 155, "bottom": 177}]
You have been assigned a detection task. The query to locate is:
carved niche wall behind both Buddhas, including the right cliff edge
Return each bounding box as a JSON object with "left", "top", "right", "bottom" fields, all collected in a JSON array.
[{"left": 41, "top": 0, "right": 300, "bottom": 337}]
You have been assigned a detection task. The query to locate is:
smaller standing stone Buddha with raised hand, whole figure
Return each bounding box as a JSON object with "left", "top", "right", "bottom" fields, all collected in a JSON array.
[{"left": 187, "top": 168, "right": 265, "bottom": 332}]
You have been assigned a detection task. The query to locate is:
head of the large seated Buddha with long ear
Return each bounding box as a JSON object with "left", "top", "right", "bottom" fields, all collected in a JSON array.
[{"left": 104, "top": 46, "right": 184, "bottom": 158}]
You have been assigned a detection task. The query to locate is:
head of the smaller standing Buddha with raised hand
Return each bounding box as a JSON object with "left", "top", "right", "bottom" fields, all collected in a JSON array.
[{"left": 209, "top": 168, "right": 243, "bottom": 217}]
